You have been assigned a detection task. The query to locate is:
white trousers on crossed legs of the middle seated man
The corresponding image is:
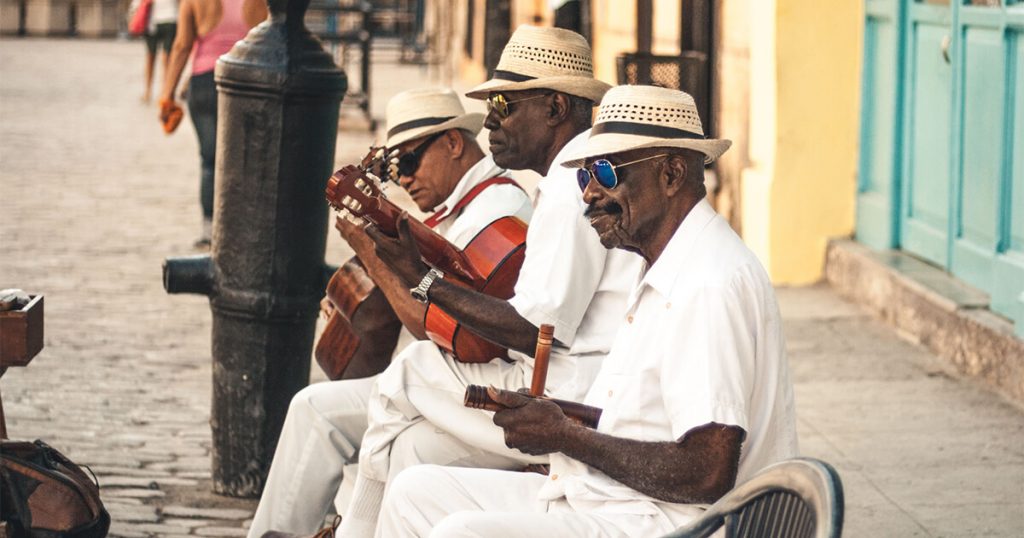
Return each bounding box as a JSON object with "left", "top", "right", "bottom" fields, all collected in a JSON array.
[{"left": 359, "top": 340, "right": 552, "bottom": 483}]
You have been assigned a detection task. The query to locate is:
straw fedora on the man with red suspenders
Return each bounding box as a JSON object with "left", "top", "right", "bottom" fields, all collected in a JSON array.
[{"left": 384, "top": 88, "right": 483, "bottom": 148}]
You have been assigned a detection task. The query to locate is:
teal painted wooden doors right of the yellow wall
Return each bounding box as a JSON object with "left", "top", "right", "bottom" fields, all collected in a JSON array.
[{"left": 857, "top": 0, "right": 1024, "bottom": 336}]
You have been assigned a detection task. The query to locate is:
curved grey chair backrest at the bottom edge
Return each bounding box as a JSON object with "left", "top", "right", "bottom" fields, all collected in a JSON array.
[{"left": 664, "top": 458, "right": 843, "bottom": 538}]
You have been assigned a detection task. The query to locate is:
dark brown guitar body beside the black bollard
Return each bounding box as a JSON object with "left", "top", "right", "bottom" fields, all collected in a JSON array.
[{"left": 313, "top": 257, "right": 401, "bottom": 381}]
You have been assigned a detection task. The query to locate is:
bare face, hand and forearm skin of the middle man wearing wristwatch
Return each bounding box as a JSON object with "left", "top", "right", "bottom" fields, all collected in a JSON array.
[{"left": 367, "top": 90, "right": 590, "bottom": 355}]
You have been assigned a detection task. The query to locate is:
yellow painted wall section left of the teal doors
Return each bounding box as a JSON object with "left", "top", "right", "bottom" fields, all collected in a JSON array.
[{"left": 742, "top": 0, "right": 863, "bottom": 284}]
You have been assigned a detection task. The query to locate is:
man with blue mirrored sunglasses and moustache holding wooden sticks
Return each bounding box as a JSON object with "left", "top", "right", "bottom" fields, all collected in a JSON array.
[{"left": 381, "top": 86, "right": 797, "bottom": 537}]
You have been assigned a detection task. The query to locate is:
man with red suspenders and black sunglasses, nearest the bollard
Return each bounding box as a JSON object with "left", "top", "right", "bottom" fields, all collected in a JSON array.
[{"left": 249, "top": 89, "right": 532, "bottom": 537}]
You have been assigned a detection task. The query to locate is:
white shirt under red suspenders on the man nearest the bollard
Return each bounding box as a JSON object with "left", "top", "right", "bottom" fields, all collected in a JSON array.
[{"left": 434, "top": 155, "right": 534, "bottom": 248}]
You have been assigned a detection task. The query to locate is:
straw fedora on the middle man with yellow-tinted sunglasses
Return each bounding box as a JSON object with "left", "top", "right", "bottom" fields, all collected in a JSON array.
[{"left": 466, "top": 25, "right": 611, "bottom": 102}]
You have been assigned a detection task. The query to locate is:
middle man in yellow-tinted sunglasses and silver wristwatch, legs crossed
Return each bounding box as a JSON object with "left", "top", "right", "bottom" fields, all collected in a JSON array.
[{"left": 341, "top": 26, "right": 641, "bottom": 536}]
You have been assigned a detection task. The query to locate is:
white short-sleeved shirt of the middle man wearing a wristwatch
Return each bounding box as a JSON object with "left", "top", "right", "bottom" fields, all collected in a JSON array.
[{"left": 509, "top": 130, "right": 643, "bottom": 401}]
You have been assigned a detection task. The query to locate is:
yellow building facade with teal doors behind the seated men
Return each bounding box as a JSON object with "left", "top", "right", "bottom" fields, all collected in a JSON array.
[{"left": 436, "top": 0, "right": 1024, "bottom": 335}]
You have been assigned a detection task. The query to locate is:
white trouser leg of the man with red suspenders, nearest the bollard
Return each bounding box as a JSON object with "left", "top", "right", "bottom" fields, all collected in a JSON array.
[{"left": 249, "top": 377, "right": 374, "bottom": 538}]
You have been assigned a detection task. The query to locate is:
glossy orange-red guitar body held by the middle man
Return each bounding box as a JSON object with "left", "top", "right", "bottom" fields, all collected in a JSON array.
[{"left": 424, "top": 216, "right": 526, "bottom": 363}]
